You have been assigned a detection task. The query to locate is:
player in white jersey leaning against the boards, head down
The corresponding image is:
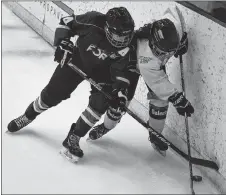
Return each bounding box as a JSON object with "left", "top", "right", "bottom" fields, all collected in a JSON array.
[{"left": 89, "top": 9, "right": 194, "bottom": 156}]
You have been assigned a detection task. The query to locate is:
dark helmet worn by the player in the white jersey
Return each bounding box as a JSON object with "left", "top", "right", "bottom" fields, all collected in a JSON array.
[{"left": 148, "top": 19, "right": 180, "bottom": 59}]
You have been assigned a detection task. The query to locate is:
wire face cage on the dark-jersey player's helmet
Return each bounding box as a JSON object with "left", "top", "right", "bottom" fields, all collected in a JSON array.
[{"left": 105, "top": 26, "right": 134, "bottom": 48}]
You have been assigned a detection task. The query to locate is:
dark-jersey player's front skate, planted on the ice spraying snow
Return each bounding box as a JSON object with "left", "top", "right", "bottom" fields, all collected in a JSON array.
[{"left": 60, "top": 123, "right": 83, "bottom": 163}]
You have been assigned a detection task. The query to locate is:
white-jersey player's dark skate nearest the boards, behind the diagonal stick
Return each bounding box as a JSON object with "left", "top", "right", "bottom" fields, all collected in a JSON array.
[{"left": 148, "top": 133, "right": 168, "bottom": 157}]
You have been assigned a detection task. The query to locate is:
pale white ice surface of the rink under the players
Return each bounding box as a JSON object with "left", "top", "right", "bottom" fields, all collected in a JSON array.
[{"left": 2, "top": 4, "right": 218, "bottom": 194}]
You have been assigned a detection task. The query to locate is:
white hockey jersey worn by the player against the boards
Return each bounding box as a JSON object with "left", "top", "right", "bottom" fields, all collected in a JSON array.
[{"left": 137, "top": 6, "right": 183, "bottom": 101}]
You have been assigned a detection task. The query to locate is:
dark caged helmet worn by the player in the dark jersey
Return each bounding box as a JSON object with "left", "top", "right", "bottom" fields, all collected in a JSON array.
[{"left": 105, "top": 7, "right": 135, "bottom": 48}]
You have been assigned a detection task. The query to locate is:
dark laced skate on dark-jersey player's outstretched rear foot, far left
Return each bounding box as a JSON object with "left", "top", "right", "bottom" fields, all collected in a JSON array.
[{"left": 6, "top": 114, "right": 34, "bottom": 133}]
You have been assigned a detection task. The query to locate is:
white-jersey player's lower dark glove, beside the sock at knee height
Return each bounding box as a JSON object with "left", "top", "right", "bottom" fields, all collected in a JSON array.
[{"left": 169, "top": 92, "right": 194, "bottom": 117}]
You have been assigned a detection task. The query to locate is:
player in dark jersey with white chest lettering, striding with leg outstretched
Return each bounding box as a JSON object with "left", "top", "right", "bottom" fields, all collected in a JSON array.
[{"left": 8, "top": 7, "right": 136, "bottom": 162}]
